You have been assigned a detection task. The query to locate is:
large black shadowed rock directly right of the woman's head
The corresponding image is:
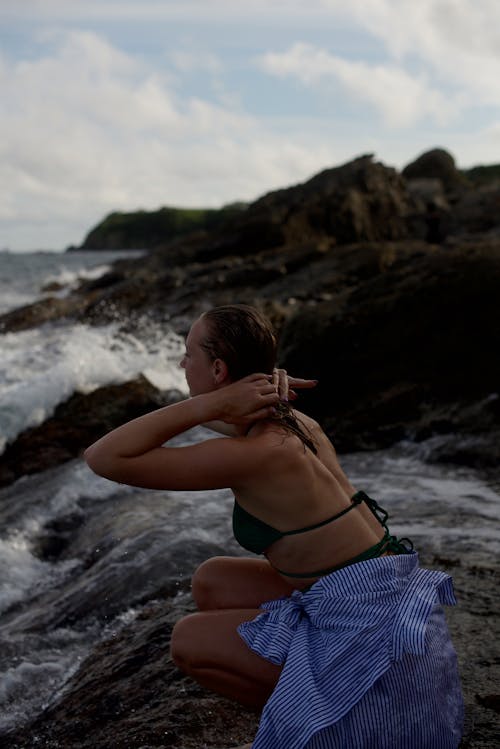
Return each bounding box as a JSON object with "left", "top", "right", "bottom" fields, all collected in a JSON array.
[{"left": 280, "top": 244, "right": 500, "bottom": 464}]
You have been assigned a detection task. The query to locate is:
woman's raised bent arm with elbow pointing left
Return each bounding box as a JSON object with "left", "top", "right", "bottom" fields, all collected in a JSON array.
[{"left": 85, "top": 374, "right": 278, "bottom": 489}]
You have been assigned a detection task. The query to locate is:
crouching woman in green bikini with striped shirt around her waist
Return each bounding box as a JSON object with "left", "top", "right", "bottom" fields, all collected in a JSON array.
[{"left": 85, "top": 305, "right": 462, "bottom": 749}]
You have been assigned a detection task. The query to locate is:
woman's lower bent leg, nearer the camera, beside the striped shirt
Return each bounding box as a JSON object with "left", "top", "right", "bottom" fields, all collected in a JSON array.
[{"left": 170, "top": 609, "right": 281, "bottom": 709}]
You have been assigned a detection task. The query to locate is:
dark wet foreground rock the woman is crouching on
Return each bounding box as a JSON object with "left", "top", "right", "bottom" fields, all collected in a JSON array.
[{"left": 3, "top": 549, "right": 500, "bottom": 749}]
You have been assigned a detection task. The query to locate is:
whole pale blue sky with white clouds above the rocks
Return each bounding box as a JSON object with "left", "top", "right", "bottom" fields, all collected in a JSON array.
[{"left": 0, "top": 0, "right": 500, "bottom": 252}]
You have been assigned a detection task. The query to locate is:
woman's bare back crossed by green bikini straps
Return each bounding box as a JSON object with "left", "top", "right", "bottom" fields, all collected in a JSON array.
[{"left": 233, "top": 413, "right": 390, "bottom": 588}]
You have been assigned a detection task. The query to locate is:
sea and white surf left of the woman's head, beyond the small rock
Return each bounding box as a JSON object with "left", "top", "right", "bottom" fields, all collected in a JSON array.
[{"left": 0, "top": 252, "right": 188, "bottom": 450}]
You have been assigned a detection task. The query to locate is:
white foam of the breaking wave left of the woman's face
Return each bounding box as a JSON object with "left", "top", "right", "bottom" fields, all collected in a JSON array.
[{"left": 0, "top": 323, "right": 186, "bottom": 450}]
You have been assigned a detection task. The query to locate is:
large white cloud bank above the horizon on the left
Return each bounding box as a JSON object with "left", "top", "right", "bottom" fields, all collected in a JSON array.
[{"left": 0, "top": 32, "right": 336, "bottom": 246}]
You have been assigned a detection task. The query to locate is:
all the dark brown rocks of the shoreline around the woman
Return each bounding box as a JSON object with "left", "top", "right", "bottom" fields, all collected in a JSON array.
[{"left": 0, "top": 151, "right": 500, "bottom": 749}]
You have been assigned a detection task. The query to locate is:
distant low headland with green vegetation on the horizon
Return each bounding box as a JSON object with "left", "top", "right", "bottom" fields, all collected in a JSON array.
[{"left": 79, "top": 203, "right": 246, "bottom": 250}]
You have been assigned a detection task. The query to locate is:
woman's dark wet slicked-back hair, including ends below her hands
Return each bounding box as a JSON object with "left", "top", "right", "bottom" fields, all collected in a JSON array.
[{"left": 201, "top": 304, "right": 317, "bottom": 453}]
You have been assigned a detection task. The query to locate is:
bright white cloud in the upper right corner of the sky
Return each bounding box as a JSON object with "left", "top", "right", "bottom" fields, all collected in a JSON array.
[{"left": 261, "top": 0, "right": 500, "bottom": 122}]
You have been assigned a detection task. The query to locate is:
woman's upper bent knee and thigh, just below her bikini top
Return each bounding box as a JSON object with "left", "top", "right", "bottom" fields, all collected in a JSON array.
[{"left": 192, "top": 557, "right": 294, "bottom": 611}]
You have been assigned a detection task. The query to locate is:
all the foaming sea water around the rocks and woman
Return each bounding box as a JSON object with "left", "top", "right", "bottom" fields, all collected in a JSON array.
[{"left": 0, "top": 253, "right": 500, "bottom": 740}]
